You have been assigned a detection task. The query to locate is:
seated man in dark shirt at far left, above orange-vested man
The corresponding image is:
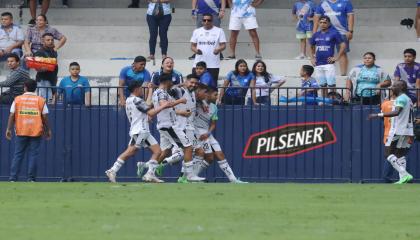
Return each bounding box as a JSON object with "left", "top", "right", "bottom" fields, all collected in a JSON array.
[{"left": 0, "top": 53, "right": 30, "bottom": 104}]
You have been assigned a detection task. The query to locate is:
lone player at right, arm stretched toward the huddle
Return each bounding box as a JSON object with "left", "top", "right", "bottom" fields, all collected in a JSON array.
[{"left": 369, "top": 81, "right": 414, "bottom": 184}]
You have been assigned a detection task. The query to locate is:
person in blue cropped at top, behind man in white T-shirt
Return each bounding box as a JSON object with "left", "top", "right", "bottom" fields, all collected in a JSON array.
[{"left": 188, "top": 0, "right": 226, "bottom": 60}]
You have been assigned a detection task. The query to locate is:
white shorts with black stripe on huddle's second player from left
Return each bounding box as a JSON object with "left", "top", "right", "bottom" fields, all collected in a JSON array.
[{"left": 159, "top": 128, "right": 192, "bottom": 151}]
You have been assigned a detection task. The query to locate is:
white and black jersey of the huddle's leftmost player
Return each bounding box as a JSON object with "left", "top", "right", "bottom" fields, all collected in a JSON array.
[{"left": 125, "top": 95, "right": 151, "bottom": 136}]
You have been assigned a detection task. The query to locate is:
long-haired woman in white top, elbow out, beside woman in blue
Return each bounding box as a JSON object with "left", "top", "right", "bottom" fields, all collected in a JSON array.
[{"left": 247, "top": 60, "right": 286, "bottom": 105}]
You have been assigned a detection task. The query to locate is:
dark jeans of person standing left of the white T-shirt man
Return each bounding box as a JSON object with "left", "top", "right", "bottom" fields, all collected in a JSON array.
[{"left": 146, "top": 14, "right": 172, "bottom": 55}]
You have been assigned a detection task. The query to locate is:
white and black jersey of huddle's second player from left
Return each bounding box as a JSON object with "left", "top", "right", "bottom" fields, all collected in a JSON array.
[{"left": 152, "top": 88, "right": 176, "bottom": 129}]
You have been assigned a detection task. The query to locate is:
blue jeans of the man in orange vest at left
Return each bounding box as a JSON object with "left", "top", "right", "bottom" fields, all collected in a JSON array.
[{"left": 9, "top": 136, "right": 41, "bottom": 181}]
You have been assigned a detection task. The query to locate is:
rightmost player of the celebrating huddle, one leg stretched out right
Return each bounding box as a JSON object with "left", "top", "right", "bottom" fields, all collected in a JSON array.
[{"left": 194, "top": 85, "right": 246, "bottom": 183}]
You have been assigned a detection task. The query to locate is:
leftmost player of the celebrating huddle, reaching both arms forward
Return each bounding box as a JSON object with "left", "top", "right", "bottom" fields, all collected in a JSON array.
[{"left": 105, "top": 81, "right": 173, "bottom": 183}]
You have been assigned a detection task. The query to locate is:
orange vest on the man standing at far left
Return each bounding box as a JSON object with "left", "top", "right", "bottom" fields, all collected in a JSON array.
[{"left": 15, "top": 94, "right": 45, "bottom": 137}]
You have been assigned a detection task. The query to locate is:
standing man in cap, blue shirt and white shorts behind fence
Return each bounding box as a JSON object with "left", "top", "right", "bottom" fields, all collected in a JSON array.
[{"left": 310, "top": 16, "right": 346, "bottom": 97}]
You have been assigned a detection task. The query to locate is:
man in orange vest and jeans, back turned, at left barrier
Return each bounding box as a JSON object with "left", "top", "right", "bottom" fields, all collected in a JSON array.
[{"left": 6, "top": 80, "right": 51, "bottom": 182}]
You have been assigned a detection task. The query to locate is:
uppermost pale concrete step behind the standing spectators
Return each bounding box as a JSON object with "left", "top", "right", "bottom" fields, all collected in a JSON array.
[{"left": 0, "top": 7, "right": 415, "bottom": 27}]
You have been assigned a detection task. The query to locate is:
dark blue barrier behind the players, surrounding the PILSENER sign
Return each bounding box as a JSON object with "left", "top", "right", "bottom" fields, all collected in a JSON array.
[{"left": 0, "top": 87, "right": 420, "bottom": 182}]
